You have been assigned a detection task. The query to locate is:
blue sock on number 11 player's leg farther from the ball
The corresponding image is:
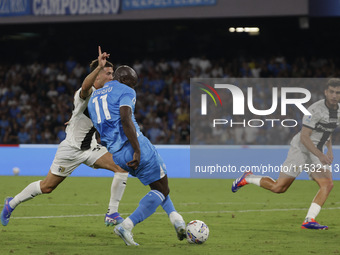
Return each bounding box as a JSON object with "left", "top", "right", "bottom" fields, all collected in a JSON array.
[{"left": 129, "top": 190, "right": 164, "bottom": 226}]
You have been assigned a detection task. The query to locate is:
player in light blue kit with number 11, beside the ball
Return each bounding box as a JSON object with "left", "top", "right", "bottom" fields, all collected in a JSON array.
[{"left": 88, "top": 66, "right": 185, "bottom": 245}]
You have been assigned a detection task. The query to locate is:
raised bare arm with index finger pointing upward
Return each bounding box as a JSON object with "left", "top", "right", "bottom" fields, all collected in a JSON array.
[{"left": 80, "top": 46, "right": 110, "bottom": 99}]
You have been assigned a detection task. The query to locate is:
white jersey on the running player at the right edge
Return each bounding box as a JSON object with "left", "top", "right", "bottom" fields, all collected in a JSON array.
[{"left": 291, "top": 99, "right": 340, "bottom": 152}]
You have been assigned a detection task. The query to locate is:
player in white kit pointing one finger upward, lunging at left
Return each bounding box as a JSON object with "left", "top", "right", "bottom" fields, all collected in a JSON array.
[{"left": 1, "top": 47, "right": 128, "bottom": 226}]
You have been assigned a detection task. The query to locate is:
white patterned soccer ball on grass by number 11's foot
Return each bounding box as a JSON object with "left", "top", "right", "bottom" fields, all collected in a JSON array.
[{"left": 185, "top": 220, "right": 209, "bottom": 244}]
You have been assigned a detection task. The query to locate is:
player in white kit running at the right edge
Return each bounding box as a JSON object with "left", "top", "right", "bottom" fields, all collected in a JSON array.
[{"left": 232, "top": 78, "right": 340, "bottom": 229}]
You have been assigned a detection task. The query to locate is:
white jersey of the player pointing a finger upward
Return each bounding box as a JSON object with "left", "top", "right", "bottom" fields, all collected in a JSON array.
[{"left": 65, "top": 88, "right": 97, "bottom": 150}]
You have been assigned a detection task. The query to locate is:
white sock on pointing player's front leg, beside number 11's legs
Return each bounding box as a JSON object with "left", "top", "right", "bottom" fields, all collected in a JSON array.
[{"left": 107, "top": 173, "right": 129, "bottom": 214}]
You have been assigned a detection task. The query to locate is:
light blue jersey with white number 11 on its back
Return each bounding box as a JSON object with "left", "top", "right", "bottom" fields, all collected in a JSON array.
[{"left": 88, "top": 81, "right": 142, "bottom": 154}]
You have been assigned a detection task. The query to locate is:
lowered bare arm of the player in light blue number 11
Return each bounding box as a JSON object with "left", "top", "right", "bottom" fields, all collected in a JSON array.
[{"left": 119, "top": 106, "right": 140, "bottom": 170}]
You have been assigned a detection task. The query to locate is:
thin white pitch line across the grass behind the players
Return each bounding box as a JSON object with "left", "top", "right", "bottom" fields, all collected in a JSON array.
[{"left": 12, "top": 207, "right": 340, "bottom": 220}]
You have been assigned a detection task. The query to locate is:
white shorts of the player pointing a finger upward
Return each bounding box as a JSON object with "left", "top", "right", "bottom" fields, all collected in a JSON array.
[{"left": 50, "top": 140, "right": 107, "bottom": 177}]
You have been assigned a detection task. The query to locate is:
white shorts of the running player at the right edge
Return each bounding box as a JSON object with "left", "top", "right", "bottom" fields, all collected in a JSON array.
[{"left": 281, "top": 142, "right": 330, "bottom": 179}]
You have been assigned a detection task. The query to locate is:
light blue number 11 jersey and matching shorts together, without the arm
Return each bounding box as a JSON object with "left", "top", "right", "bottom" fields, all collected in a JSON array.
[{"left": 88, "top": 81, "right": 166, "bottom": 185}]
